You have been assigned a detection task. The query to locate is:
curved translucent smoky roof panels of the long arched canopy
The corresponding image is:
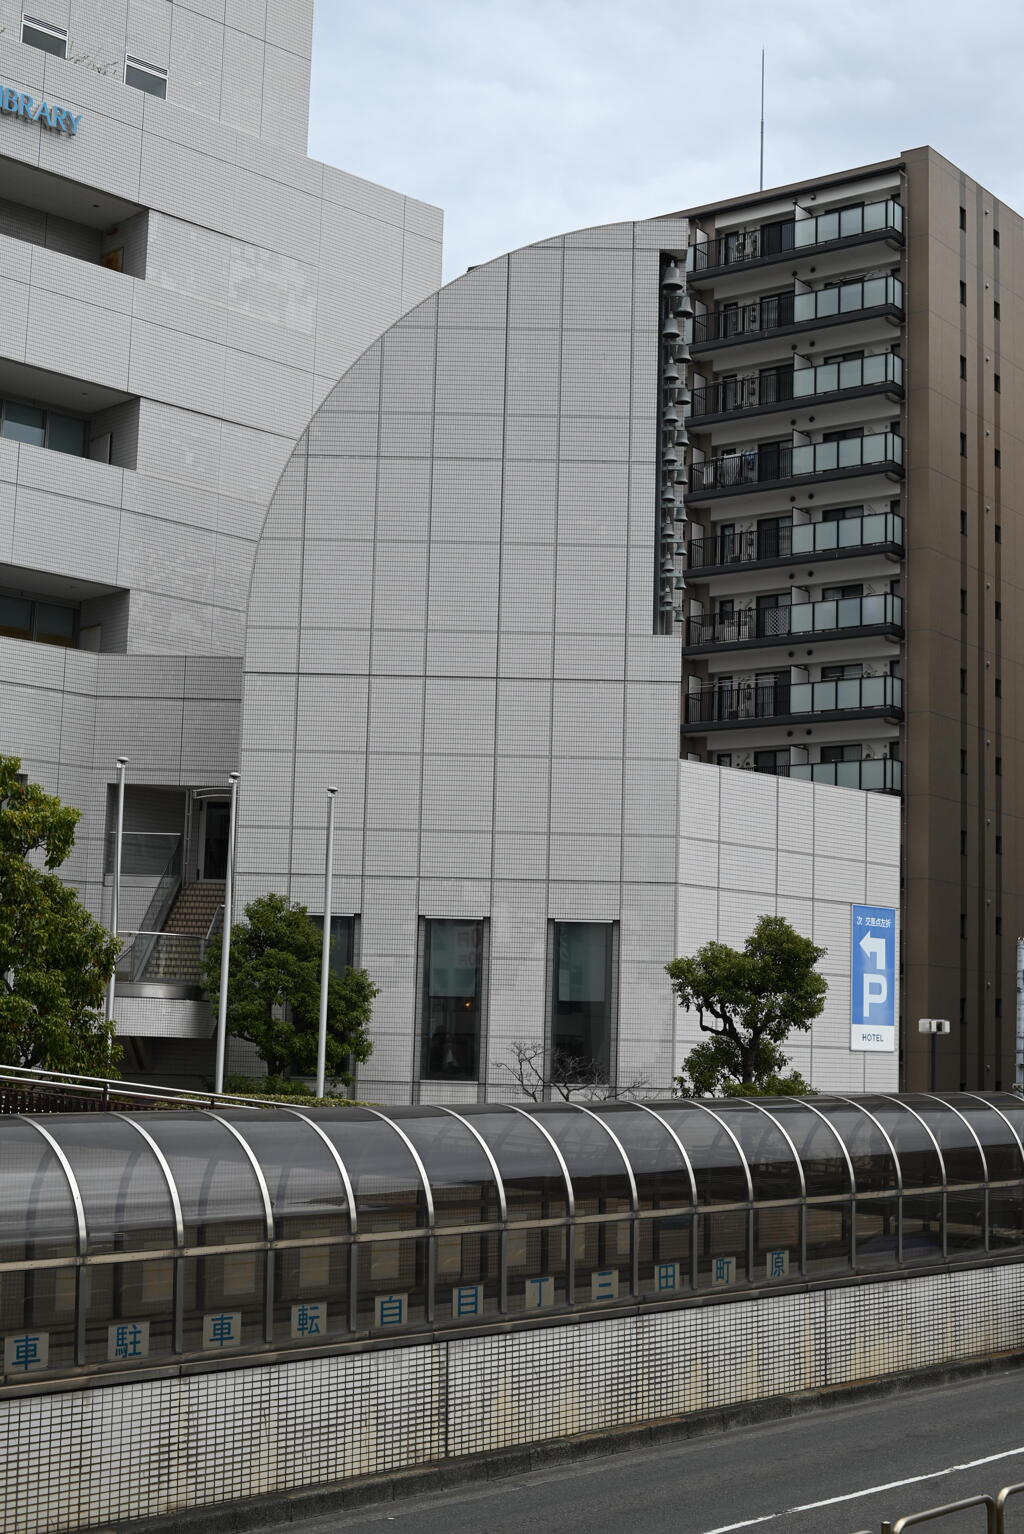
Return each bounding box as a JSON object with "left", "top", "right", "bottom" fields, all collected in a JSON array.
[{"left": 0, "top": 1092, "right": 1024, "bottom": 1262}]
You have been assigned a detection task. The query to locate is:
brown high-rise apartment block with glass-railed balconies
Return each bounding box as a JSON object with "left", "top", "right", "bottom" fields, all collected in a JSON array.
[{"left": 674, "top": 147, "right": 1024, "bottom": 1091}]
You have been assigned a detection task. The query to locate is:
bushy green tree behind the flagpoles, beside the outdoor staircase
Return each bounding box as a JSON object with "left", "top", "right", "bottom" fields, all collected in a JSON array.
[{"left": 207, "top": 894, "right": 379, "bottom": 1081}]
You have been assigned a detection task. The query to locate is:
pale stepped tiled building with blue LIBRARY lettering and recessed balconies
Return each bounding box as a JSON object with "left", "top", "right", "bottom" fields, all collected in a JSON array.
[{"left": 0, "top": 0, "right": 441, "bottom": 1074}]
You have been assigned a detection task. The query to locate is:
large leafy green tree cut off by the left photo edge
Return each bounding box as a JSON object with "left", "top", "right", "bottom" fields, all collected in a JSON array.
[{"left": 0, "top": 756, "right": 121, "bottom": 1075}]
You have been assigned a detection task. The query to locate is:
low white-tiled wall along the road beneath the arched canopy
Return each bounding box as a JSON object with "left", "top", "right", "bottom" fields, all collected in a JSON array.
[{"left": 0, "top": 1266, "right": 1024, "bottom": 1534}]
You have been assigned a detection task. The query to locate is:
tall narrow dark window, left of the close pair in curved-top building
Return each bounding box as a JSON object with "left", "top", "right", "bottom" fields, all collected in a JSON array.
[{"left": 422, "top": 920, "right": 483, "bottom": 1081}]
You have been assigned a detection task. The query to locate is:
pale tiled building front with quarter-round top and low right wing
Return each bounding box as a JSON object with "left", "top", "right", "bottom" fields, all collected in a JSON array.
[{"left": 239, "top": 221, "right": 898, "bottom": 1101}]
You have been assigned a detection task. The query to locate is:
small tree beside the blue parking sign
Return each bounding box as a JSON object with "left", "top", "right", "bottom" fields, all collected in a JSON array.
[{"left": 665, "top": 916, "right": 828, "bottom": 1097}]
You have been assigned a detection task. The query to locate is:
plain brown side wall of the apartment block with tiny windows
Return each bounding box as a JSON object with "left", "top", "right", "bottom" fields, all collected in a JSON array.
[{"left": 903, "top": 149, "right": 1024, "bottom": 1089}]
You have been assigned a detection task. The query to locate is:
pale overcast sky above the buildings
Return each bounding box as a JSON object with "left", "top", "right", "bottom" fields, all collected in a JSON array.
[{"left": 310, "top": 0, "right": 1024, "bottom": 281}]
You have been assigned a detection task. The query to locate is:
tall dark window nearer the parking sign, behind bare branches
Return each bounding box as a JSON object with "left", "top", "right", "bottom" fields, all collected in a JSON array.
[{"left": 550, "top": 922, "right": 613, "bottom": 1081}]
